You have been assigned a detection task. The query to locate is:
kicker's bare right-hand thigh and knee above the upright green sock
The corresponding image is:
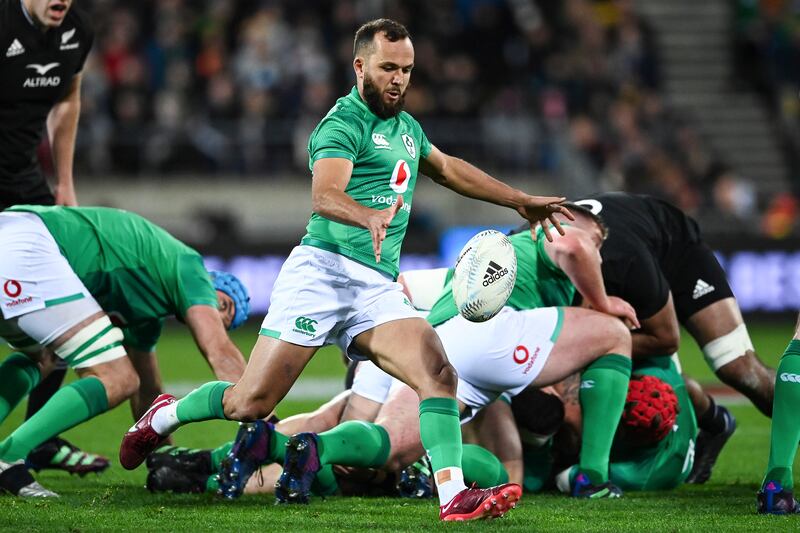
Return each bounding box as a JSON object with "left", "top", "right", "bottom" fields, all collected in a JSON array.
[{"left": 353, "top": 318, "right": 455, "bottom": 393}]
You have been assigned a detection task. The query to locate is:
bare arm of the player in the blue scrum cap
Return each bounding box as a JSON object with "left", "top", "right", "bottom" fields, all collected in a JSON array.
[{"left": 185, "top": 305, "right": 245, "bottom": 383}]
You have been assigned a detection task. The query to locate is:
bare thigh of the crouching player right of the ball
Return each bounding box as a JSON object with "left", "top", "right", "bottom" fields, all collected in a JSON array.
[{"left": 533, "top": 307, "right": 631, "bottom": 387}]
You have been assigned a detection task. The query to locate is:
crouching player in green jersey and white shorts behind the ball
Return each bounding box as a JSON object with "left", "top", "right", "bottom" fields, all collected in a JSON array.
[{"left": 188, "top": 212, "right": 637, "bottom": 501}]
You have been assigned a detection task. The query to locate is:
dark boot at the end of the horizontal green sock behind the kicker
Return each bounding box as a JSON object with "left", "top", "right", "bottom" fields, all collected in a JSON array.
[{"left": 275, "top": 433, "right": 322, "bottom": 503}]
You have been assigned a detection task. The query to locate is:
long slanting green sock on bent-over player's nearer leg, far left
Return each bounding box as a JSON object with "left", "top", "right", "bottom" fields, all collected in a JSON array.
[{"left": 0, "top": 377, "right": 108, "bottom": 462}]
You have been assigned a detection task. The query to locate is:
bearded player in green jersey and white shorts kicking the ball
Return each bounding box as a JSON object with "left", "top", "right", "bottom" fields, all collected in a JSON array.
[{"left": 120, "top": 19, "right": 569, "bottom": 520}]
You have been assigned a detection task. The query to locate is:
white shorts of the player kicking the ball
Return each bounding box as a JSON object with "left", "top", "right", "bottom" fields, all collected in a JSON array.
[{"left": 260, "top": 245, "right": 423, "bottom": 360}]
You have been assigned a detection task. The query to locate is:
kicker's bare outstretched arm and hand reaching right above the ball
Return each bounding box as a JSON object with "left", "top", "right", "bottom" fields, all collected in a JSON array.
[{"left": 420, "top": 146, "right": 573, "bottom": 241}]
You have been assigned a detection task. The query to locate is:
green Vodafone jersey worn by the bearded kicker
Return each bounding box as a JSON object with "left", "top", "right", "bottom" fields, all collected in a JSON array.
[{"left": 301, "top": 87, "right": 432, "bottom": 279}]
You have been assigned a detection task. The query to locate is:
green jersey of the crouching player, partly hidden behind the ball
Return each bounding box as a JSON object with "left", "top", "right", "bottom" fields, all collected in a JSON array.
[{"left": 428, "top": 227, "right": 575, "bottom": 326}]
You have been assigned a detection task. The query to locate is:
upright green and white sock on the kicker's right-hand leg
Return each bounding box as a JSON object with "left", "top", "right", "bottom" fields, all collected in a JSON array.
[{"left": 419, "top": 398, "right": 467, "bottom": 505}]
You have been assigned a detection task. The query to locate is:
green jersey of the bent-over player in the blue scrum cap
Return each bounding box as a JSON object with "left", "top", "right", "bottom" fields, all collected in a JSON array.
[{"left": 9, "top": 205, "right": 217, "bottom": 351}]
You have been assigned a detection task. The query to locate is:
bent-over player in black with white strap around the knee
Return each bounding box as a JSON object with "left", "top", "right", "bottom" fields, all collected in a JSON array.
[{"left": 564, "top": 193, "right": 775, "bottom": 483}]
